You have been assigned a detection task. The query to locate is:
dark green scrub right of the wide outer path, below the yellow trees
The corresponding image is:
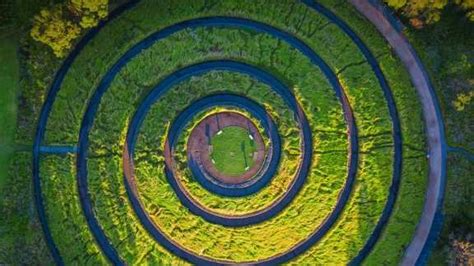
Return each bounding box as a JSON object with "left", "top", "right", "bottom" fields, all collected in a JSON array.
[{"left": 408, "top": 8, "right": 474, "bottom": 152}]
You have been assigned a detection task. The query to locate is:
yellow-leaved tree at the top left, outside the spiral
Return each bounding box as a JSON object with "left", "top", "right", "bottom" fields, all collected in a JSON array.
[{"left": 30, "top": 0, "right": 109, "bottom": 58}]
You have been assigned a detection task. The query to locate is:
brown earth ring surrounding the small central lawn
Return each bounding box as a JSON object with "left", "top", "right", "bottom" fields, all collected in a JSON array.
[{"left": 187, "top": 111, "right": 265, "bottom": 184}]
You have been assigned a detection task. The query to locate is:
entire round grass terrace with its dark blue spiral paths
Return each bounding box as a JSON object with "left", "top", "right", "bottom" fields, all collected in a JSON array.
[{"left": 33, "top": 0, "right": 434, "bottom": 265}]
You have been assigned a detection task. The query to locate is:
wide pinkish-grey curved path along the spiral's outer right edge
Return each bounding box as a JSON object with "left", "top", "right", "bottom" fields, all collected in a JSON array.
[{"left": 350, "top": 0, "right": 446, "bottom": 265}]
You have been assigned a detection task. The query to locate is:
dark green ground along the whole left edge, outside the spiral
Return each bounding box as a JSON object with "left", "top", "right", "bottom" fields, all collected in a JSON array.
[{"left": 0, "top": 0, "right": 65, "bottom": 265}]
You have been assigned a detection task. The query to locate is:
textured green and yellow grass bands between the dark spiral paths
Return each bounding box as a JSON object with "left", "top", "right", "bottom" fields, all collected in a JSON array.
[{"left": 4, "top": 0, "right": 434, "bottom": 265}]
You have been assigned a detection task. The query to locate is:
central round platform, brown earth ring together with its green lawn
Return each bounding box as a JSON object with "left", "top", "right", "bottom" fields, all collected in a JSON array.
[{"left": 187, "top": 111, "right": 266, "bottom": 184}]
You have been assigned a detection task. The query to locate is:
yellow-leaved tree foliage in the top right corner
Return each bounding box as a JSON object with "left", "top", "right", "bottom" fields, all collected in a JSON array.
[{"left": 385, "top": 0, "right": 474, "bottom": 28}]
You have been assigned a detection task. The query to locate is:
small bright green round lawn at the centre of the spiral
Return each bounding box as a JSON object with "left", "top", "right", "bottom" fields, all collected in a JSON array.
[{"left": 211, "top": 126, "right": 256, "bottom": 176}]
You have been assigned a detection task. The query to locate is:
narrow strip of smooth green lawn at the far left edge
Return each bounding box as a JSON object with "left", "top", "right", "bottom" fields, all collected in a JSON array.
[{"left": 0, "top": 36, "right": 19, "bottom": 189}]
